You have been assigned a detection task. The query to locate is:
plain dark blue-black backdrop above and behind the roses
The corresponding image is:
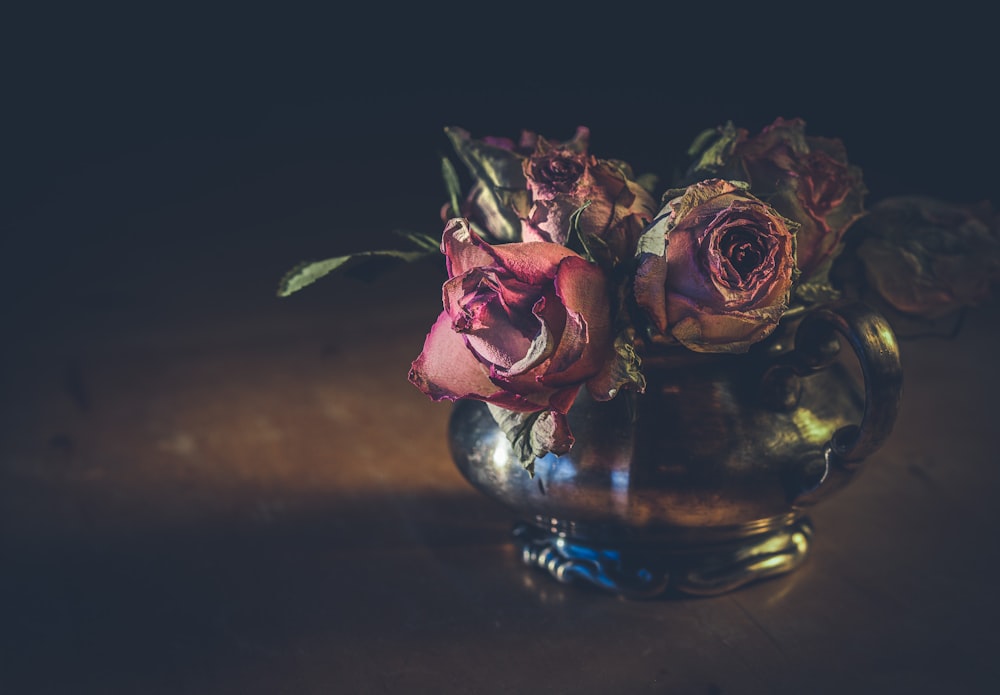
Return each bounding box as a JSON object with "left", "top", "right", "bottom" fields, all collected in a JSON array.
[{"left": 0, "top": 6, "right": 1000, "bottom": 335}]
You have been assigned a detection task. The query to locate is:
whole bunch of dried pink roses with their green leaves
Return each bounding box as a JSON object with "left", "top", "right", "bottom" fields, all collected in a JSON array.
[{"left": 279, "top": 118, "right": 1000, "bottom": 474}]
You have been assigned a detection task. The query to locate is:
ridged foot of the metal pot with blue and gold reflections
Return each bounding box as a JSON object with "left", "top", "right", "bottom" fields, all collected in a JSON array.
[{"left": 513, "top": 517, "right": 813, "bottom": 599}]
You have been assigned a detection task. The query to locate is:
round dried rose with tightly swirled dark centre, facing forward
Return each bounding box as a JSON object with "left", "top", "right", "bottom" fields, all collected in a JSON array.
[{"left": 635, "top": 179, "right": 795, "bottom": 353}]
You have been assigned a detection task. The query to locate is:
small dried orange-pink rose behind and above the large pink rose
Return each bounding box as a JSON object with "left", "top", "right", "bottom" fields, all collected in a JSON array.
[{"left": 519, "top": 137, "right": 656, "bottom": 264}]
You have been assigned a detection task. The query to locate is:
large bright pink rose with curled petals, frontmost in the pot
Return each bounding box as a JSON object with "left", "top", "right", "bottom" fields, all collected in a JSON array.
[{"left": 409, "top": 218, "right": 612, "bottom": 454}]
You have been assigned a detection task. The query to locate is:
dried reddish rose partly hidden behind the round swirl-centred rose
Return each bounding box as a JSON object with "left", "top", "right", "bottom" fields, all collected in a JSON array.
[{"left": 692, "top": 118, "right": 867, "bottom": 284}]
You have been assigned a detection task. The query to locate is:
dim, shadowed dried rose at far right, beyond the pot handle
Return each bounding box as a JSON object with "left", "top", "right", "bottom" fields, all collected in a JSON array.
[{"left": 852, "top": 196, "right": 1000, "bottom": 319}]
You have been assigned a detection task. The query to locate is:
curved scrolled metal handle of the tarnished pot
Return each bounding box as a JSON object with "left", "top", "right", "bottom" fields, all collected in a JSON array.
[{"left": 789, "top": 301, "right": 903, "bottom": 506}]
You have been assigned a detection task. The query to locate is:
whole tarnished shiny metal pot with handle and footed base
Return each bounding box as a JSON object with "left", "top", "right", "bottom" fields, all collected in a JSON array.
[{"left": 449, "top": 303, "right": 901, "bottom": 597}]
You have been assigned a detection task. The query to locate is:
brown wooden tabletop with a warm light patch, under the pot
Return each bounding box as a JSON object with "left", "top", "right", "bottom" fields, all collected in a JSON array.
[{"left": 0, "top": 235, "right": 1000, "bottom": 695}]
